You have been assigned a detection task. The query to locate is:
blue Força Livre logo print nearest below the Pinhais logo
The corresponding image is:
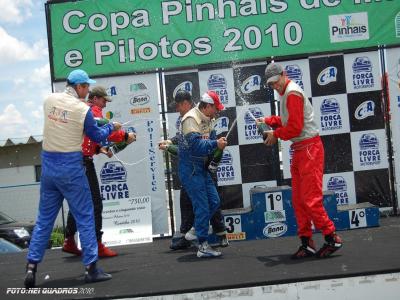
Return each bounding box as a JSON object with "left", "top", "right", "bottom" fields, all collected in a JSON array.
[{"left": 353, "top": 56, "right": 374, "bottom": 89}]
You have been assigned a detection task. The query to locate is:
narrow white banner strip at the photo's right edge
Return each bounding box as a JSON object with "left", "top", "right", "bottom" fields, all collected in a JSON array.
[{"left": 386, "top": 48, "right": 400, "bottom": 204}]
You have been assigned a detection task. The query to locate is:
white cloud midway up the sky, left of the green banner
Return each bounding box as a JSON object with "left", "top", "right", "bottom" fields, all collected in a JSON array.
[{"left": 0, "top": 27, "right": 48, "bottom": 65}]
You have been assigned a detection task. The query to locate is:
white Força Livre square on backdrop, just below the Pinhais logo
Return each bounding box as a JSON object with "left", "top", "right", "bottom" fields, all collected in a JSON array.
[{"left": 344, "top": 51, "right": 381, "bottom": 93}]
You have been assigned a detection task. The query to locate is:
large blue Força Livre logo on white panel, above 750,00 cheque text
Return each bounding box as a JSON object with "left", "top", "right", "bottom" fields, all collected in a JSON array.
[{"left": 100, "top": 161, "right": 129, "bottom": 201}]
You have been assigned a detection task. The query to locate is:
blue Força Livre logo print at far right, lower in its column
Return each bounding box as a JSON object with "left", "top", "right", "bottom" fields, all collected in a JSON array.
[{"left": 359, "top": 133, "right": 381, "bottom": 166}]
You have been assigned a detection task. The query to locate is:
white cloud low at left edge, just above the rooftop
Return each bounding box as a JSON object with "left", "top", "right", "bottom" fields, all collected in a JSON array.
[{"left": 0, "top": 104, "right": 30, "bottom": 139}]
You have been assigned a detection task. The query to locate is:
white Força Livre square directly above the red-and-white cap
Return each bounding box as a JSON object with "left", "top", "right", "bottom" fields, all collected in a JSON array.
[{"left": 199, "top": 69, "right": 236, "bottom": 107}]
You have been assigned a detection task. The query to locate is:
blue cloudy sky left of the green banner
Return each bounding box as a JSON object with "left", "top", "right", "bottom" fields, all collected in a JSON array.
[{"left": 0, "top": 0, "right": 51, "bottom": 141}]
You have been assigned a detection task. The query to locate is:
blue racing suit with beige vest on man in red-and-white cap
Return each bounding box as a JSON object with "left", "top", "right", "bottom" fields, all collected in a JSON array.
[{"left": 178, "top": 107, "right": 220, "bottom": 243}]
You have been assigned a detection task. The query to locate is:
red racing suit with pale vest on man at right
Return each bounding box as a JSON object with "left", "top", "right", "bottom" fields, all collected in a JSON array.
[{"left": 264, "top": 79, "right": 335, "bottom": 238}]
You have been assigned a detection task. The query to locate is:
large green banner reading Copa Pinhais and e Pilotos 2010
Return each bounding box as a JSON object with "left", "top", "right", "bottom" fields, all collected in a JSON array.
[{"left": 46, "top": 0, "right": 400, "bottom": 80}]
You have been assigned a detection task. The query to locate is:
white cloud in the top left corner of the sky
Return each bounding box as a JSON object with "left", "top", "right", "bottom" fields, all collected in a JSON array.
[{"left": 0, "top": 0, "right": 33, "bottom": 24}]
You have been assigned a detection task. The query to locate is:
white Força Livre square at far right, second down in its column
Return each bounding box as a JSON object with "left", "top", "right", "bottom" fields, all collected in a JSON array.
[{"left": 350, "top": 129, "right": 388, "bottom": 171}]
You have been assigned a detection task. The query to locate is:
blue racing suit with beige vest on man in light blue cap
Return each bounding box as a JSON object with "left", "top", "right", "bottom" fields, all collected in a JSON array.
[{"left": 27, "top": 90, "right": 114, "bottom": 266}]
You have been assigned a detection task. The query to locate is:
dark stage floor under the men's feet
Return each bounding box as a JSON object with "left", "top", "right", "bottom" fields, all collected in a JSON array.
[{"left": 0, "top": 217, "right": 400, "bottom": 299}]
